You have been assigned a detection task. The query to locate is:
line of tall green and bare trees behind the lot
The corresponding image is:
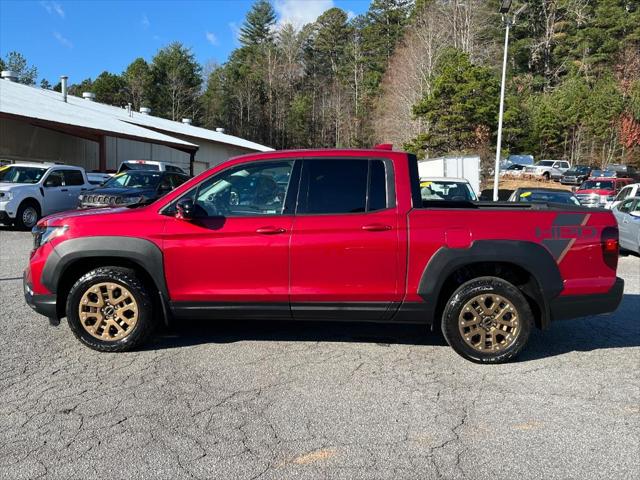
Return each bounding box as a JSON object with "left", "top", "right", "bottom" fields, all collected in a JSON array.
[{"left": 2, "top": 0, "right": 640, "bottom": 165}]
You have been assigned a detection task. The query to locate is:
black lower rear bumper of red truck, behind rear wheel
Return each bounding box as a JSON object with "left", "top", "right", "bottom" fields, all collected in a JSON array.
[{"left": 549, "top": 278, "right": 624, "bottom": 320}]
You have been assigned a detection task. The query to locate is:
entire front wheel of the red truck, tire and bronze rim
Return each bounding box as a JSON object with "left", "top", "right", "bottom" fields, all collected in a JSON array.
[{"left": 67, "top": 267, "right": 153, "bottom": 352}]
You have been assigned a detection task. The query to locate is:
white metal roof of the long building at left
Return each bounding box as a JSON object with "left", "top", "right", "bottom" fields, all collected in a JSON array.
[{"left": 0, "top": 80, "right": 273, "bottom": 152}]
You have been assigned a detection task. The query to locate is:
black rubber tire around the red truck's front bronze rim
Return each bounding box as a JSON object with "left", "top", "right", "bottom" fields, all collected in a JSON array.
[{"left": 66, "top": 267, "right": 155, "bottom": 352}]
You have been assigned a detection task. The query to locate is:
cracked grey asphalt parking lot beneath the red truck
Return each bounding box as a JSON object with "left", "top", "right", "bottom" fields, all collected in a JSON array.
[{"left": 0, "top": 230, "right": 640, "bottom": 480}]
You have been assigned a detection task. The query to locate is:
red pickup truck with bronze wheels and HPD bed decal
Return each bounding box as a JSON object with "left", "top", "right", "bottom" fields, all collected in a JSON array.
[{"left": 24, "top": 149, "right": 623, "bottom": 363}]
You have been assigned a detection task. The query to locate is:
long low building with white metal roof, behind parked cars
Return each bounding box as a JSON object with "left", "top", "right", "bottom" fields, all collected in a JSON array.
[{"left": 0, "top": 72, "right": 272, "bottom": 174}]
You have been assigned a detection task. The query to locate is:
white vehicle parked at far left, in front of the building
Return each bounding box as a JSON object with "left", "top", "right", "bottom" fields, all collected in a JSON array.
[{"left": 0, "top": 163, "right": 94, "bottom": 229}]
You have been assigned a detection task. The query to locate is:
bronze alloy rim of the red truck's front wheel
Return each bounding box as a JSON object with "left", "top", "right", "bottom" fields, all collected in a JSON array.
[{"left": 78, "top": 282, "right": 138, "bottom": 341}]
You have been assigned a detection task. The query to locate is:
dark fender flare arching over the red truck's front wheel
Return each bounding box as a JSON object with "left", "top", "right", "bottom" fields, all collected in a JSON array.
[{"left": 41, "top": 236, "right": 169, "bottom": 320}]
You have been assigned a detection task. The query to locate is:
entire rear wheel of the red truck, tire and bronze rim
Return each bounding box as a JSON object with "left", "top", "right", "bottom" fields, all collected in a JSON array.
[{"left": 442, "top": 277, "right": 533, "bottom": 363}]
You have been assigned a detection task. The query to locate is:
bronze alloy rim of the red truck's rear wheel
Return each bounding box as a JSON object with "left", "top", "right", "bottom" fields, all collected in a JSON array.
[{"left": 458, "top": 293, "right": 520, "bottom": 352}]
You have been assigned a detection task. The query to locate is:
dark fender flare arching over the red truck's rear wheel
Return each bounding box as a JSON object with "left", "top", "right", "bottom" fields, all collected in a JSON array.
[{"left": 418, "top": 240, "right": 564, "bottom": 328}]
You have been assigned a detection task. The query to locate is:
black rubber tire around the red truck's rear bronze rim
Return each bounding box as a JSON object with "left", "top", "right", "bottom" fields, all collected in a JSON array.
[{"left": 442, "top": 277, "right": 533, "bottom": 363}]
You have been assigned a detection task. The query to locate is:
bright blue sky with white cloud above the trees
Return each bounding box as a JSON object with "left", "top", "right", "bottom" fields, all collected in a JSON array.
[{"left": 0, "top": 0, "right": 369, "bottom": 84}]
